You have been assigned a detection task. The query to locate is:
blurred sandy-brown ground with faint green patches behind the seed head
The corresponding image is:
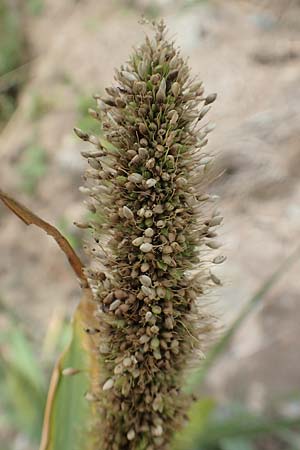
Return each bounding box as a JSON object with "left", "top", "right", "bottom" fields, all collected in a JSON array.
[{"left": 0, "top": 0, "right": 300, "bottom": 450}]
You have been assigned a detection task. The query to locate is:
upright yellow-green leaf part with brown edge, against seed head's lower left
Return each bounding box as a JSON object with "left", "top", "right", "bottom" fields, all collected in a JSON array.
[{"left": 40, "top": 291, "right": 98, "bottom": 450}]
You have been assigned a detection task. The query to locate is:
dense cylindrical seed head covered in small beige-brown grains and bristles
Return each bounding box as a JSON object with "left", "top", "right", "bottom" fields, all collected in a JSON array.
[{"left": 76, "top": 22, "right": 224, "bottom": 450}]
